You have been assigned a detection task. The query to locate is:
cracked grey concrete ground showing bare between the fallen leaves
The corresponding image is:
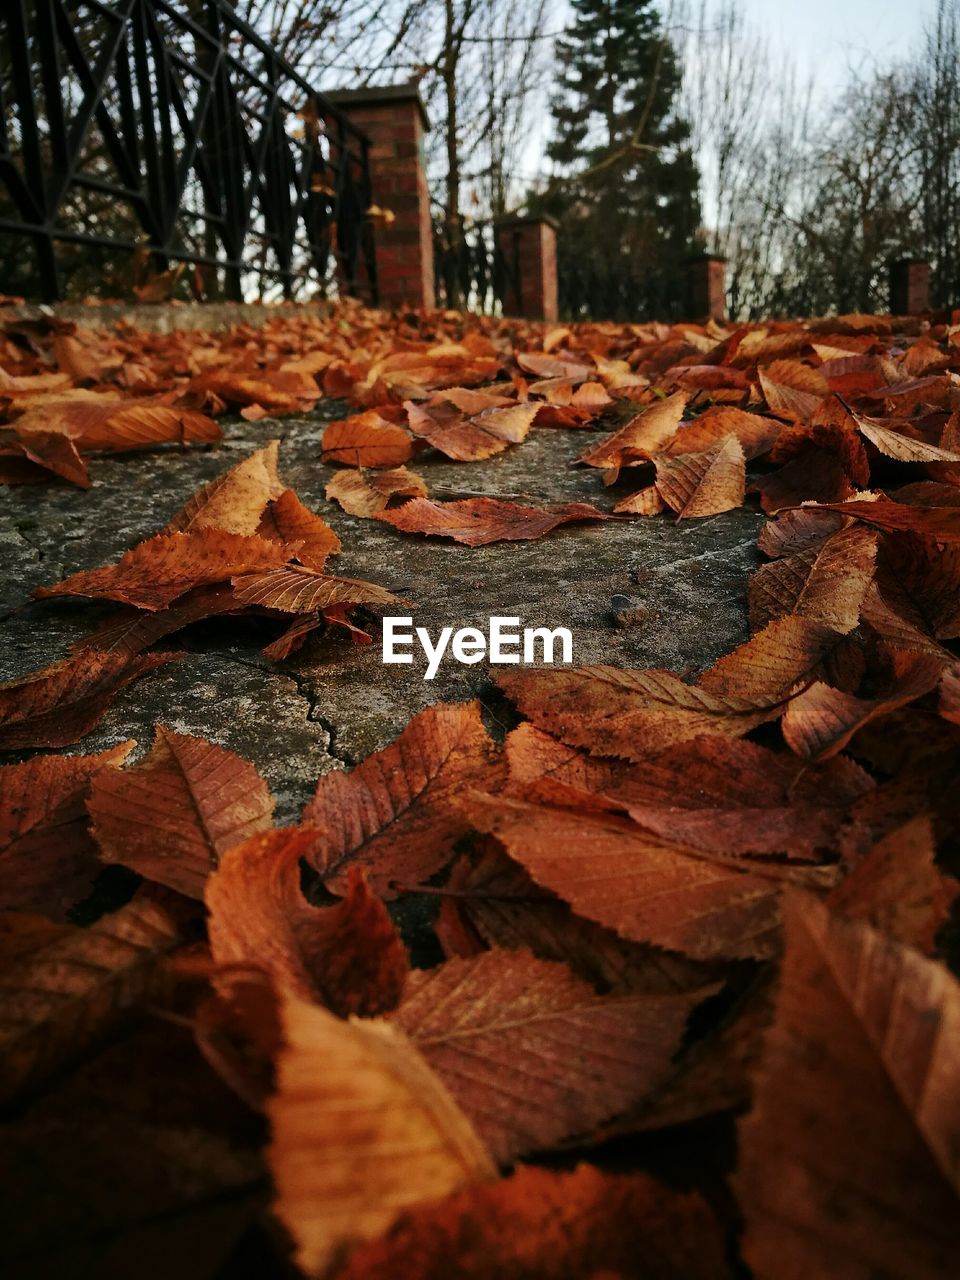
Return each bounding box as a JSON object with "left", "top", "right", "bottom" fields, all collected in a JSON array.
[{"left": 0, "top": 402, "right": 760, "bottom": 823}]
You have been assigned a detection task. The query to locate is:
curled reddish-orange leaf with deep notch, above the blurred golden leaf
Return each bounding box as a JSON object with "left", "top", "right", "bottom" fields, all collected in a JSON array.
[{"left": 205, "top": 827, "right": 408, "bottom": 1018}]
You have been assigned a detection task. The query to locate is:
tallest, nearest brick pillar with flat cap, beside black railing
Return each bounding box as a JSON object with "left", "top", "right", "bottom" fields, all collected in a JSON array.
[{"left": 324, "top": 84, "right": 436, "bottom": 307}]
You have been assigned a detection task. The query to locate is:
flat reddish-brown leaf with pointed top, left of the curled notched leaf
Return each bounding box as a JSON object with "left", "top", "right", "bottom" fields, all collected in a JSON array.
[{"left": 87, "top": 724, "right": 274, "bottom": 899}]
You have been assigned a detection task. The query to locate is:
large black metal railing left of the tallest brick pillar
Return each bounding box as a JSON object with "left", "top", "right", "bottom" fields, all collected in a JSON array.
[{"left": 0, "top": 0, "right": 376, "bottom": 301}]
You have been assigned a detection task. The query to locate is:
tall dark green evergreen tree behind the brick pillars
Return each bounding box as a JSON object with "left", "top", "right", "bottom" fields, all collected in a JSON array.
[{"left": 531, "top": 0, "right": 700, "bottom": 314}]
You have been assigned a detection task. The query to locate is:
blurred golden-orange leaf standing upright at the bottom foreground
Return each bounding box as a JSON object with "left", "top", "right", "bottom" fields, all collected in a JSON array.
[{"left": 269, "top": 993, "right": 495, "bottom": 1275}]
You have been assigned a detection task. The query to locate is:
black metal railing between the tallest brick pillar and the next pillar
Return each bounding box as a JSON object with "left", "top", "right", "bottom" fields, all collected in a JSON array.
[{"left": 434, "top": 210, "right": 517, "bottom": 315}]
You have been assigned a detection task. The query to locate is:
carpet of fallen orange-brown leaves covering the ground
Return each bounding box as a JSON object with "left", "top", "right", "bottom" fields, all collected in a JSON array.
[{"left": 0, "top": 294, "right": 960, "bottom": 1280}]
